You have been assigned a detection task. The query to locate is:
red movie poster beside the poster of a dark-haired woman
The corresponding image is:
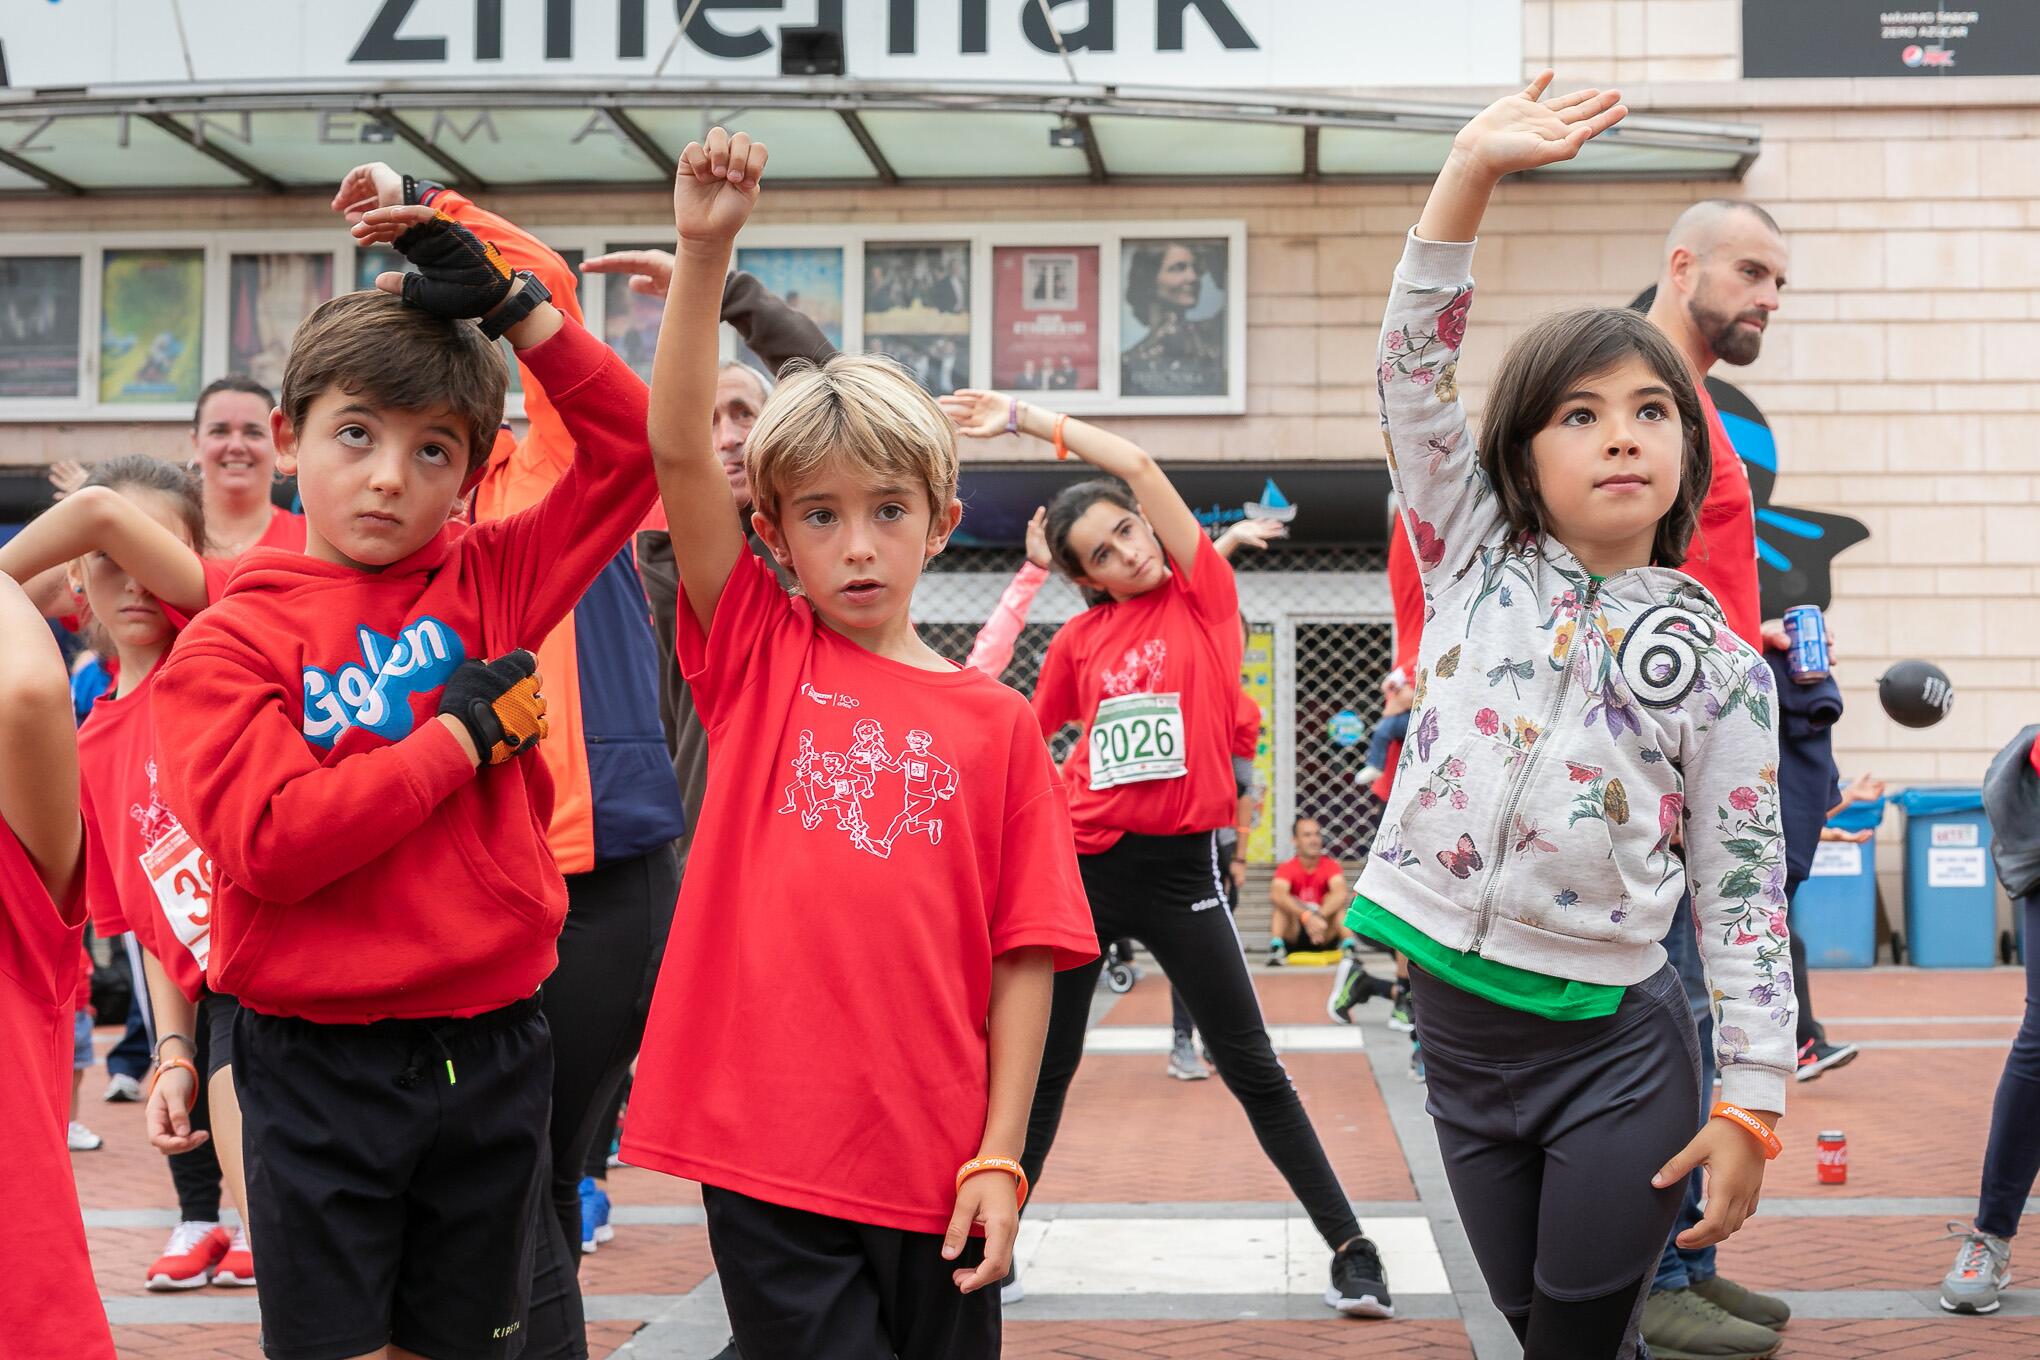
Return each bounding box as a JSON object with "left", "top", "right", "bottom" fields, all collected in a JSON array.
[{"left": 991, "top": 245, "right": 1098, "bottom": 391}]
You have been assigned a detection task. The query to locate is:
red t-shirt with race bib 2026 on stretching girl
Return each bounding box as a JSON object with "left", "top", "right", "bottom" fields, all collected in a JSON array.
[{"left": 1034, "top": 538, "right": 1242, "bottom": 854}]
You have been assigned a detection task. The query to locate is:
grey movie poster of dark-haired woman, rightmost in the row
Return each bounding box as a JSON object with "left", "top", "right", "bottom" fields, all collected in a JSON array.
[{"left": 1120, "top": 237, "right": 1232, "bottom": 398}]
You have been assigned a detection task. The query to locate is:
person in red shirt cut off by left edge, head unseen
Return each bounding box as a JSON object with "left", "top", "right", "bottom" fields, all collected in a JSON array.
[{"left": 0, "top": 575, "right": 114, "bottom": 1360}]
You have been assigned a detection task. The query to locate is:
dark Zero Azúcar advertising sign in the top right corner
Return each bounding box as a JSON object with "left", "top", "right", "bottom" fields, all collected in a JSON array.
[{"left": 1742, "top": 0, "right": 2040, "bottom": 80}]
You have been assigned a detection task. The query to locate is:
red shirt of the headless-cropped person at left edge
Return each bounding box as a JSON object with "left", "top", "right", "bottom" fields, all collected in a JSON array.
[{"left": 0, "top": 826, "right": 114, "bottom": 1360}]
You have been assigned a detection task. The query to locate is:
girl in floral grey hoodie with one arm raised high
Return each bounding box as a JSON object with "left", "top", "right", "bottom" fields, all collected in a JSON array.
[{"left": 1348, "top": 71, "right": 1793, "bottom": 1360}]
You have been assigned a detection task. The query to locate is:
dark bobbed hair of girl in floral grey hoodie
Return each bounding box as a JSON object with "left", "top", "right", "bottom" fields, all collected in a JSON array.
[{"left": 1481, "top": 308, "right": 1714, "bottom": 567}]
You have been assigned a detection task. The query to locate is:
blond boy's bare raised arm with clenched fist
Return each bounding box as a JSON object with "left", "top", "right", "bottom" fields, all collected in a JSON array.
[{"left": 647, "top": 128, "right": 765, "bottom": 632}]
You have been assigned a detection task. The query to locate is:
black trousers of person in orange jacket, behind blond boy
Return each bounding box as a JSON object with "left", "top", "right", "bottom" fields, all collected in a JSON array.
[{"left": 524, "top": 846, "right": 679, "bottom": 1360}]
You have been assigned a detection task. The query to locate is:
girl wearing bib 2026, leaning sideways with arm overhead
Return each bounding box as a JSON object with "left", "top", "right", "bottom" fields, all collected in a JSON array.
[{"left": 940, "top": 389, "right": 1393, "bottom": 1317}]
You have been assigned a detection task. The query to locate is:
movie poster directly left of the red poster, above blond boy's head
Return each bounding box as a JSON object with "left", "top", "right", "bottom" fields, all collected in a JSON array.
[{"left": 865, "top": 241, "right": 971, "bottom": 396}]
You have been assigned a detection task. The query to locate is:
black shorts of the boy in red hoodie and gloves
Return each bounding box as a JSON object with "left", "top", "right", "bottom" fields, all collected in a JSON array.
[{"left": 235, "top": 997, "right": 553, "bottom": 1360}]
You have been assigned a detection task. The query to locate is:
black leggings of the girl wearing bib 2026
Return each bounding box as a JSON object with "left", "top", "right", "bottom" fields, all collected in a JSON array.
[{"left": 1020, "top": 832, "right": 1361, "bottom": 1250}]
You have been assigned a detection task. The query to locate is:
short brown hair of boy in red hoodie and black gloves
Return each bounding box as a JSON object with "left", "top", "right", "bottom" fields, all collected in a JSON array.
[{"left": 282, "top": 290, "right": 510, "bottom": 473}]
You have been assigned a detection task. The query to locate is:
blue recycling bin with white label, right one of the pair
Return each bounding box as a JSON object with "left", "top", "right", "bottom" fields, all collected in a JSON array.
[{"left": 1899, "top": 787, "right": 1997, "bottom": 969}]
